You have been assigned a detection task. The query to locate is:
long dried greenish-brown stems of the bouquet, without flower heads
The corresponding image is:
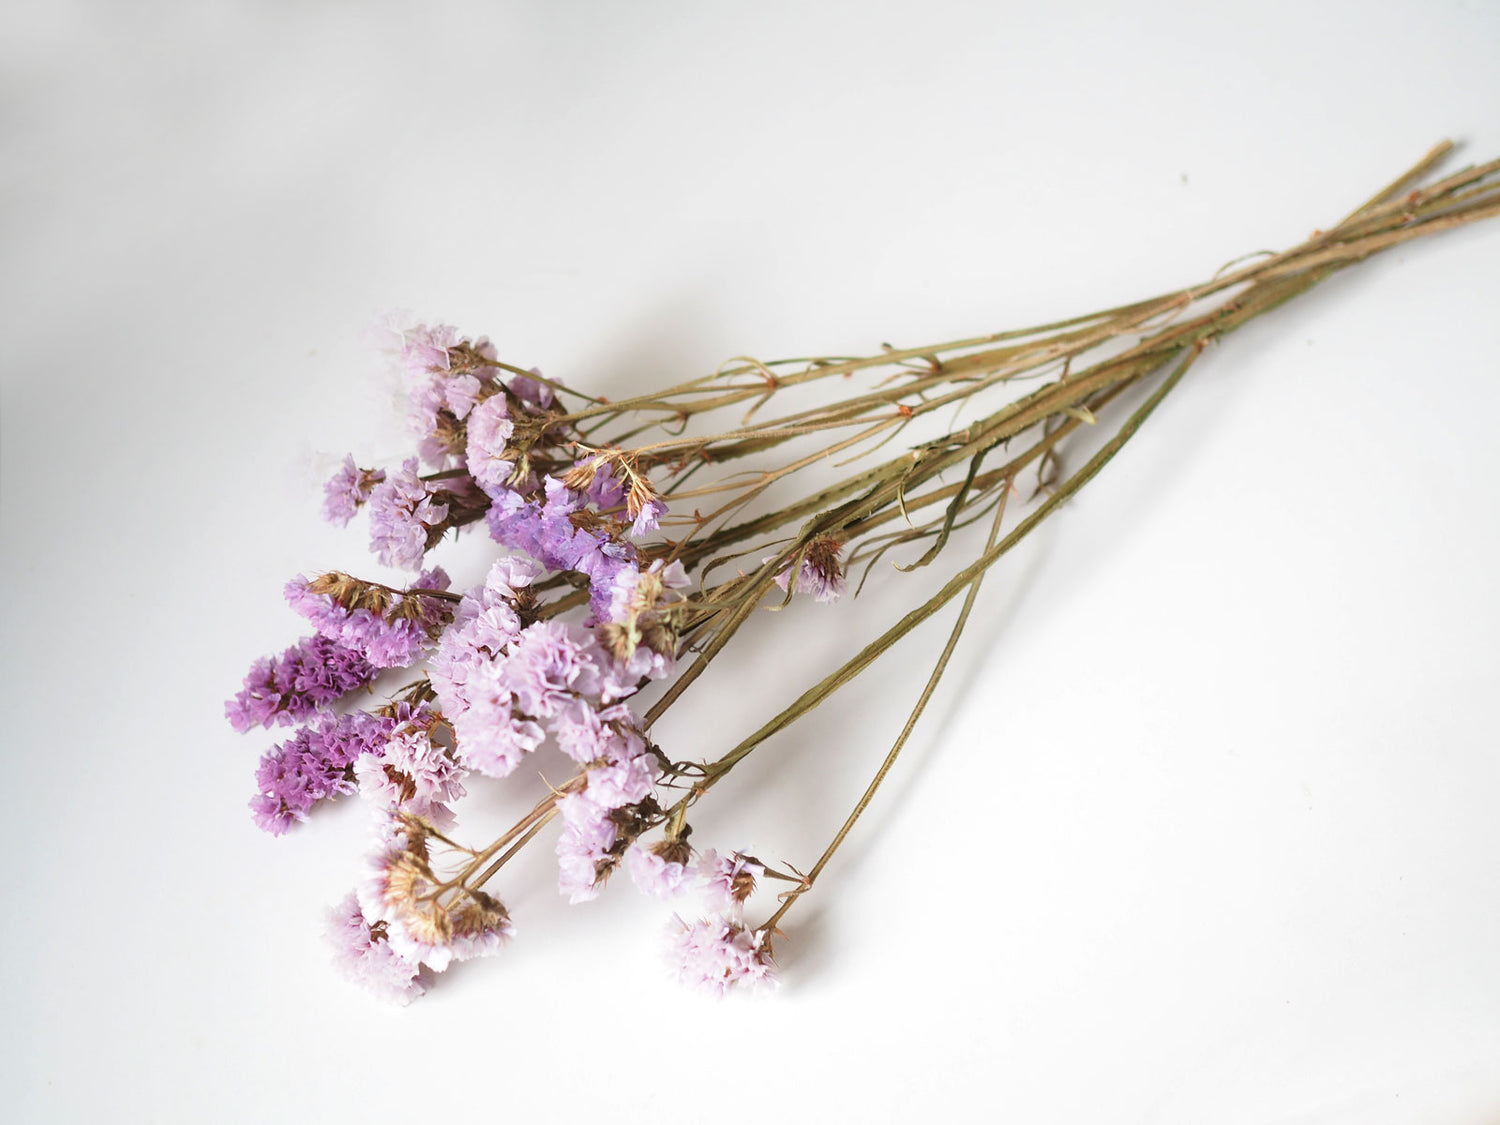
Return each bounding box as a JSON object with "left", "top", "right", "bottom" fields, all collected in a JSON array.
[{"left": 486, "top": 141, "right": 1500, "bottom": 927}]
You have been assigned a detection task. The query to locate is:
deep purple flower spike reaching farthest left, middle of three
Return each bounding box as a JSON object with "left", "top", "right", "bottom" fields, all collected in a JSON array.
[{"left": 224, "top": 635, "right": 377, "bottom": 732}]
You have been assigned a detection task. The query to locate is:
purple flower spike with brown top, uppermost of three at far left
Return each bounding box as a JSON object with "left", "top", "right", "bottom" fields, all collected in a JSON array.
[{"left": 284, "top": 567, "right": 452, "bottom": 668}]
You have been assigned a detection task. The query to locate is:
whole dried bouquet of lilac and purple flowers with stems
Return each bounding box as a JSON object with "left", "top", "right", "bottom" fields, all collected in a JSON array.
[{"left": 227, "top": 143, "right": 1500, "bottom": 1002}]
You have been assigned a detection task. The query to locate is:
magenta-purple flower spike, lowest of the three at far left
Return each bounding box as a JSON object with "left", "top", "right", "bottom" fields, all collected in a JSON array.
[{"left": 251, "top": 711, "right": 395, "bottom": 836}]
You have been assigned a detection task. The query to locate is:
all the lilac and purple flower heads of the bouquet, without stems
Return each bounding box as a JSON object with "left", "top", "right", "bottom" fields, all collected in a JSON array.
[{"left": 227, "top": 326, "right": 798, "bottom": 1002}]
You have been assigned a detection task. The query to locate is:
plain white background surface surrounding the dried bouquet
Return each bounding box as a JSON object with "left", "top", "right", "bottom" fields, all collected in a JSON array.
[{"left": 0, "top": 0, "right": 1500, "bottom": 1124}]
